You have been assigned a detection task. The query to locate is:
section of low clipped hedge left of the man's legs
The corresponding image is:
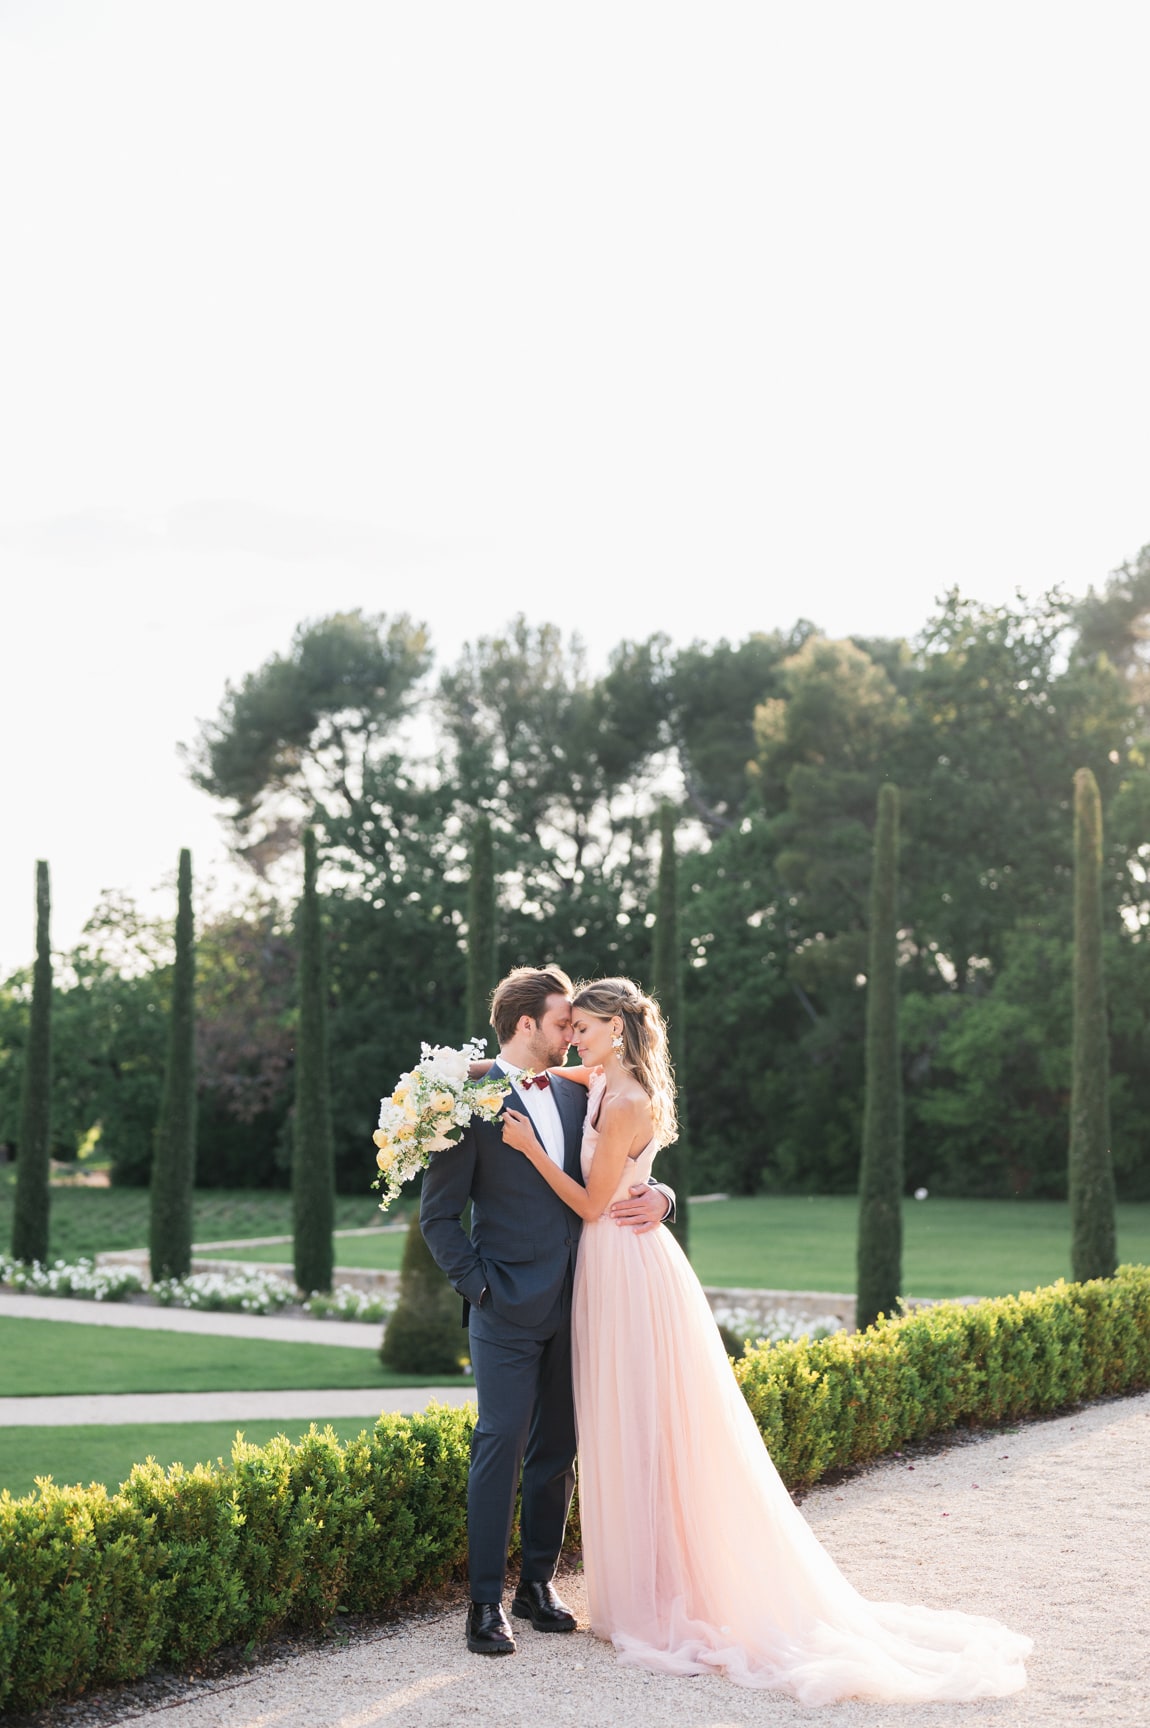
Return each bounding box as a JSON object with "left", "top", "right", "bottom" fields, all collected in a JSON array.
[{"left": 0, "top": 1407, "right": 473, "bottom": 1709}]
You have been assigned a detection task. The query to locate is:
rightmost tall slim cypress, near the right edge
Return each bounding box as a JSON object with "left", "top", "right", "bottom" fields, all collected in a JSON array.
[{"left": 1069, "top": 767, "right": 1117, "bottom": 1279}]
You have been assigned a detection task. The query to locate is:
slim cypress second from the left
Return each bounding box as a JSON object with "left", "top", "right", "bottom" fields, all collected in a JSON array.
[{"left": 150, "top": 847, "right": 195, "bottom": 1279}]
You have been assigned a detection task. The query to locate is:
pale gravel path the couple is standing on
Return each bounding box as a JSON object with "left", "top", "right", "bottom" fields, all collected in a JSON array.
[{"left": 60, "top": 1394, "right": 1150, "bottom": 1728}]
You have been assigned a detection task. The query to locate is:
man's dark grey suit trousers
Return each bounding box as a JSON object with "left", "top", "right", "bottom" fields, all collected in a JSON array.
[{"left": 468, "top": 1274, "right": 575, "bottom": 1602}]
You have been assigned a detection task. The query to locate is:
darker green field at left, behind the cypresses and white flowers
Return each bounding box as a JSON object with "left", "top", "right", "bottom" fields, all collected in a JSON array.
[{"left": 0, "top": 1170, "right": 385, "bottom": 1260}]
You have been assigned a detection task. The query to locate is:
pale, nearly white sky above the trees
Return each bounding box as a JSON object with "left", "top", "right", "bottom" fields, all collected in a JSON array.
[{"left": 0, "top": 0, "right": 1150, "bottom": 975}]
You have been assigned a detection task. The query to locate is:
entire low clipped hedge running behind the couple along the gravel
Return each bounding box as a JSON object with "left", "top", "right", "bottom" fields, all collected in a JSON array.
[{"left": 0, "top": 1267, "right": 1150, "bottom": 1709}]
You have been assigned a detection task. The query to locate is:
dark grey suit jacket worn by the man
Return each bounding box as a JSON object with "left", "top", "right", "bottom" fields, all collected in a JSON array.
[{"left": 420, "top": 1063, "right": 587, "bottom": 1331}]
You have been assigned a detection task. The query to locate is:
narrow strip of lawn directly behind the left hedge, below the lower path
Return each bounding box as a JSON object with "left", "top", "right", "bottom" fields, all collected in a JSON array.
[{"left": 0, "top": 1415, "right": 390, "bottom": 1496}]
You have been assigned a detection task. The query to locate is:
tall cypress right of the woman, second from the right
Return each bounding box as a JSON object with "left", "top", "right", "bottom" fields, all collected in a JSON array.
[{"left": 856, "top": 785, "right": 903, "bottom": 1329}]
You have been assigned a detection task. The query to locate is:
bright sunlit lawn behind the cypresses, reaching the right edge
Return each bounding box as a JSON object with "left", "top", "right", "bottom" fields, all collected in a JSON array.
[{"left": 203, "top": 1194, "right": 1150, "bottom": 1296}]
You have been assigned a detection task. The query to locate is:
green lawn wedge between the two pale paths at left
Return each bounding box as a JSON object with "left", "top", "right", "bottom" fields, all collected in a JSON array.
[{"left": 0, "top": 1317, "right": 464, "bottom": 1398}]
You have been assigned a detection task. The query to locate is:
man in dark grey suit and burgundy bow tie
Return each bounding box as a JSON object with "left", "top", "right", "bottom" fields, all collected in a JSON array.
[{"left": 420, "top": 966, "right": 675, "bottom": 1655}]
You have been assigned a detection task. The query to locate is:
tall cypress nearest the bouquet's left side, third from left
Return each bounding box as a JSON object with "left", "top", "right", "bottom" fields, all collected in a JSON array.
[{"left": 292, "top": 828, "right": 335, "bottom": 1293}]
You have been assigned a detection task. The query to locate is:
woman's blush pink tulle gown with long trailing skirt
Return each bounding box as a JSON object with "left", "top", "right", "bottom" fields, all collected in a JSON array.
[{"left": 572, "top": 1080, "right": 1031, "bottom": 1704}]
